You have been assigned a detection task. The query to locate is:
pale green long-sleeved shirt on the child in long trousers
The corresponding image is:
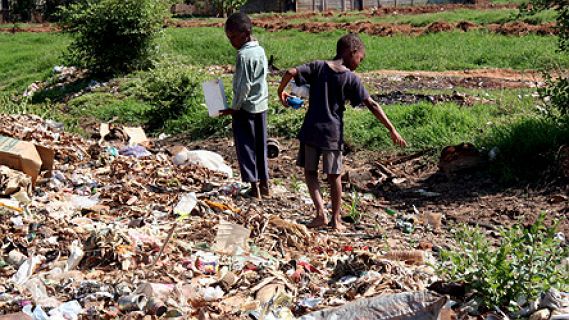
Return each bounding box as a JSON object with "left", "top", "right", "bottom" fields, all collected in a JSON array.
[{"left": 231, "top": 41, "right": 269, "bottom": 113}]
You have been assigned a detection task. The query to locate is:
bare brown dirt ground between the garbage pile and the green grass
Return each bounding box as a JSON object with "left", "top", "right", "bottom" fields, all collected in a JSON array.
[{"left": 169, "top": 137, "right": 569, "bottom": 248}]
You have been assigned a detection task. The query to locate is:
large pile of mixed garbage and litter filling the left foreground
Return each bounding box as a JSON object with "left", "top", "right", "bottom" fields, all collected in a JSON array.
[{"left": 0, "top": 115, "right": 446, "bottom": 320}]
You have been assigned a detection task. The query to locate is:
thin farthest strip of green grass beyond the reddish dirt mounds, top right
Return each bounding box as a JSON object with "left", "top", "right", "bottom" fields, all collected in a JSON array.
[{"left": 289, "top": 9, "right": 556, "bottom": 27}]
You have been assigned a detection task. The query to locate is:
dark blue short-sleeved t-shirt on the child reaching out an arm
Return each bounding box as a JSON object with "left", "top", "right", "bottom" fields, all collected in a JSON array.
[{"left": 294, "top": 61, "right": 369, "bottom": 150}]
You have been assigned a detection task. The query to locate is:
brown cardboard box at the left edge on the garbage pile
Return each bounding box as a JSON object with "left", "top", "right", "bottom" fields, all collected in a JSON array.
[{"left": 0, "top": 135, "right": 55, "bottom": 185}]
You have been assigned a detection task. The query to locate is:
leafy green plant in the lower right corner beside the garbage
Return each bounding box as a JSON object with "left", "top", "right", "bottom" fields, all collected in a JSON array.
[{"left": 437, "top": 214, "right": 569, "bottom": 311}]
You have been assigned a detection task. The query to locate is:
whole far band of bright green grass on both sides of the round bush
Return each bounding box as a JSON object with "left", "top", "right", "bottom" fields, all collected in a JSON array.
[{"left": 0, "top": 28, "right": 569, "bottom": 91}]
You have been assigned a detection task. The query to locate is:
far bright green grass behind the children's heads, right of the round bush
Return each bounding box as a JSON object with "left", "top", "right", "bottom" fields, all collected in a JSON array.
[{"left": 167, "top": 28, "right": 569, "bottom": 71}]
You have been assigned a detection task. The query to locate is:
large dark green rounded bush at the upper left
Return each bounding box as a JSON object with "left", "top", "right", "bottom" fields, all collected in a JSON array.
[{"left": 61, "top": 0, "right": 167, "bottom": 75}]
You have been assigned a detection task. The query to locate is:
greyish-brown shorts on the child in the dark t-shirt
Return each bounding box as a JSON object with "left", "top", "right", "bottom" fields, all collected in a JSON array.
[{"left": 296, "top": 143, "right": 342, "bottom": 174}]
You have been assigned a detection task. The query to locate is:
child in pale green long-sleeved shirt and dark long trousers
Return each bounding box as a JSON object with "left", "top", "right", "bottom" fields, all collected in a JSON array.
[{"left": 222, "top": 13, "right": 270, "bottom": 198}]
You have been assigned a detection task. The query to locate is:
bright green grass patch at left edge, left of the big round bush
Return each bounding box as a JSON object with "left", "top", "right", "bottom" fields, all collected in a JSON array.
[{"left": 0, "top": 33, "right": 69, "bottom": 92}]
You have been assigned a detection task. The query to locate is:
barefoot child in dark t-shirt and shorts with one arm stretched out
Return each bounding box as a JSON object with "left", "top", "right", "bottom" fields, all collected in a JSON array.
[{"left": 278, "top": 33, "right": 407, "bottom": 230}]
